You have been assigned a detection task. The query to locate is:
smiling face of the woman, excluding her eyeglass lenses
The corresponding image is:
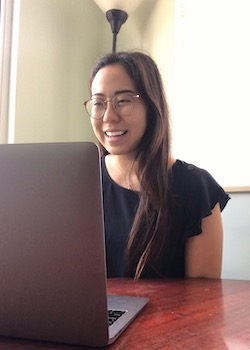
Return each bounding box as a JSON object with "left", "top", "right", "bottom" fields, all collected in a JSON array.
[{"left": 91, "top": 64, "right": 147, "bottom": 156}]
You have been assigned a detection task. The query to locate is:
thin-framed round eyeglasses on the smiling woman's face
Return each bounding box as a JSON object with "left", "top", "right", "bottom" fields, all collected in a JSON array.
[{"left": 83, "top": 93, "right": 140, "bottom": 119}]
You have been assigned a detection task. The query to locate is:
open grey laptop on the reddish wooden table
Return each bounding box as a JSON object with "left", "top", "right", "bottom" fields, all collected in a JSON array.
[{"left": 0, "top": 142, "right": 148, "bottom": 347}]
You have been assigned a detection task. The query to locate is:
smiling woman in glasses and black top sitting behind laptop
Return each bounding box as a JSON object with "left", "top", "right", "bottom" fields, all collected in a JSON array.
[{"left": 84, "top": 52, "right": 229, "bottom": 279}]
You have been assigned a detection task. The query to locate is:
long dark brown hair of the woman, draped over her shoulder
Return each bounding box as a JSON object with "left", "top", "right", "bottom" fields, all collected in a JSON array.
[{"left": 90, "top": 51, "right": 173, "bottom": 279}]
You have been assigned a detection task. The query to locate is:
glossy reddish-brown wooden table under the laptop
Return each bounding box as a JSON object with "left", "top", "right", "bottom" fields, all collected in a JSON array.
[{"left": 0, "top": 279, "right": 250, "bottom": 350}]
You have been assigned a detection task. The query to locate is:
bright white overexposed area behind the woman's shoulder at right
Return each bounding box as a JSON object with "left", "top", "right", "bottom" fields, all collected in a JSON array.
[{"left": 173, "top": 0, "right": 250, "bottom": 191}]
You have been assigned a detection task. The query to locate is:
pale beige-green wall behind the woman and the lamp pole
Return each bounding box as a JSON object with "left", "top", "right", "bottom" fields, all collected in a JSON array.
[{"left": 14, "top": 0, "right": 174, "bottom": 143}]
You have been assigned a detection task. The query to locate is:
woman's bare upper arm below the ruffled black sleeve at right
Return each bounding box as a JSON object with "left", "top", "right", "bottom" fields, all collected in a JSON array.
[{"left": 185, "top": 203, "right": 223, "bottom": 278}]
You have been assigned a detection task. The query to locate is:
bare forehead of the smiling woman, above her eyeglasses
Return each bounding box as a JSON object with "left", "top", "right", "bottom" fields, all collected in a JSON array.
[{"left": 91, "top": 64, "right": 136, "bottom": 94}]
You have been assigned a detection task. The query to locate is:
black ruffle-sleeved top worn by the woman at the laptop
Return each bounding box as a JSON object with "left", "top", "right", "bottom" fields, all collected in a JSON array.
[{"left": 101, "top": 157, "right": 230, "bottom": 278}]
